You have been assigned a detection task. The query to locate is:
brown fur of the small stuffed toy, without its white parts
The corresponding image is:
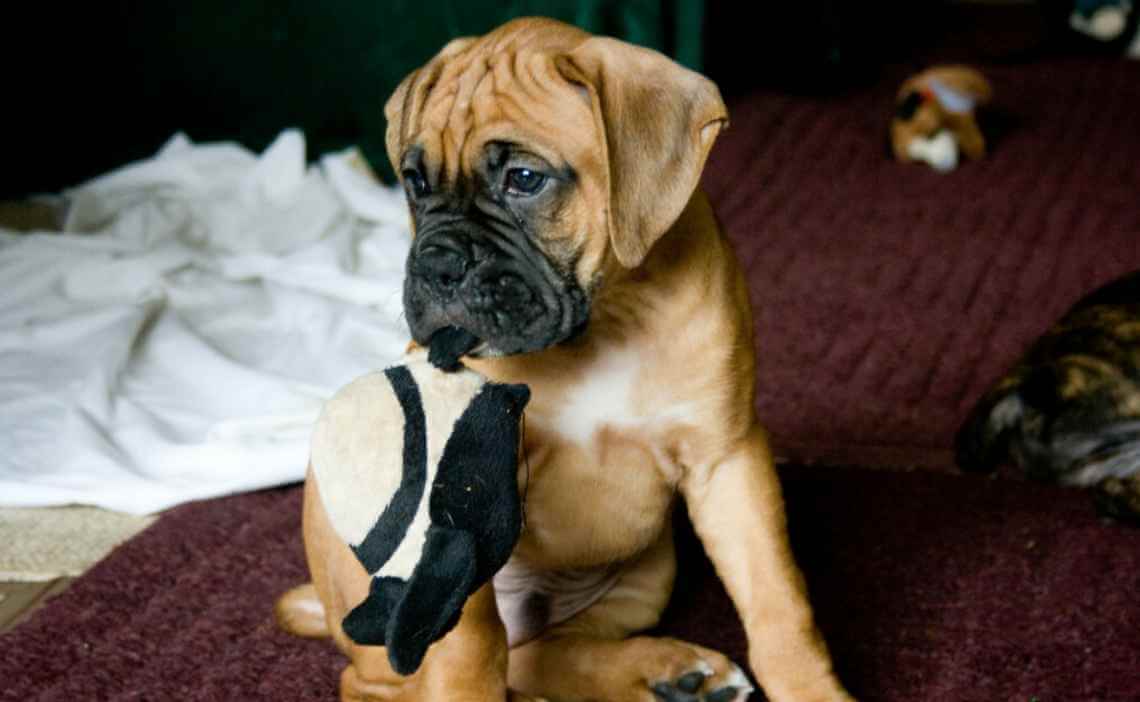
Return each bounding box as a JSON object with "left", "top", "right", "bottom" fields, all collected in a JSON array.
[{"left": 890, "top": 66, "right": 993, "bottom": 161}]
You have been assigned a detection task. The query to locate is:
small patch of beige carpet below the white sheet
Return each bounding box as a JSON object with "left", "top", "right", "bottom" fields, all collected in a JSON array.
[{"left": 0, "top": 507, "right": 155, "bottom": 582}]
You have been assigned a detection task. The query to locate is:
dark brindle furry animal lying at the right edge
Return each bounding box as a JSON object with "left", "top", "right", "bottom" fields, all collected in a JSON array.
[{"left": 955, "top": 271, "right": 1140, "bottom": 525}]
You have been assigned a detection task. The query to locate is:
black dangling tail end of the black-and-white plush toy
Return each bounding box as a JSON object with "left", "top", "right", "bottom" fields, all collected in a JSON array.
[{"left": 342, "top": 525, "right": 475, "bottom": 676}]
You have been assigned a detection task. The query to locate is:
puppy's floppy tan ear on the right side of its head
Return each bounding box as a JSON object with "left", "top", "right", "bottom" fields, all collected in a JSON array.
[{"left": 556, "top": 36, "right": 728, "bottom": 268}]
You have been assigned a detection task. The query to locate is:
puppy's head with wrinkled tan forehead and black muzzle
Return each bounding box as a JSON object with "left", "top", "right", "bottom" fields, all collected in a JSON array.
[{"left": 385, "top": 19, "right": 726, "bottom": 356}]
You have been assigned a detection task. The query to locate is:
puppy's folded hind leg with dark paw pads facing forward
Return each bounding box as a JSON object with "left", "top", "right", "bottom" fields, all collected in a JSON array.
[{"left": 507, "top": 528, "right": 752, "bottom": 702}]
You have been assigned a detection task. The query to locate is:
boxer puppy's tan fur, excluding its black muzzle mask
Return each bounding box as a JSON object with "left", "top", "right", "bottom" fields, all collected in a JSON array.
[{"left": 278, "top": 19, "right": 850, "bottom": 702}]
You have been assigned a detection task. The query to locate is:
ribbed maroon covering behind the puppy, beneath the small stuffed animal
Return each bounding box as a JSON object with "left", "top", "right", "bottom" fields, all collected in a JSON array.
[{"left": 705, "top": 59, "right": 1140, "bottom": 467}]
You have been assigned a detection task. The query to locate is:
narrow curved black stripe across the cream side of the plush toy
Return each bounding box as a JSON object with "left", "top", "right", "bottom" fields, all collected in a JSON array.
[{"left": 352, "top": 366, "right": 428, "bottom": 574}]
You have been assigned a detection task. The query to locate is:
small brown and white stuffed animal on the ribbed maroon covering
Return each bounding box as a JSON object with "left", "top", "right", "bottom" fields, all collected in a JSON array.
[{"left": 890, "top": 66, "right": 993, "bottom": 172}]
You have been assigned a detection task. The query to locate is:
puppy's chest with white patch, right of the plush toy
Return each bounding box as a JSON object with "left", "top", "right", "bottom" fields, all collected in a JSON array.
[{"left": 519, "top": 351, "right": 687, "bottom": 566}]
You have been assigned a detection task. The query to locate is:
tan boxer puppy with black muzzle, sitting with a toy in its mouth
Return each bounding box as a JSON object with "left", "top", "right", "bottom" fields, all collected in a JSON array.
[{"left": 278, "top": 19, "right": 850, "bottom": 702}]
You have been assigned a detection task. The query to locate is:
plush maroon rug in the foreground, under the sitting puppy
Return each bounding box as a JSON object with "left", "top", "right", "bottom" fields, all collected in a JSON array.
[{"left": 0, "top": 467, "right": 1140, "bottom": 702}]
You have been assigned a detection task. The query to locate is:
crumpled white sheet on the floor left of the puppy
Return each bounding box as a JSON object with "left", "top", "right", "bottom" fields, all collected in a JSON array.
[{"left": 0, "top": 131, "right": 409, "bottom": 514}]
